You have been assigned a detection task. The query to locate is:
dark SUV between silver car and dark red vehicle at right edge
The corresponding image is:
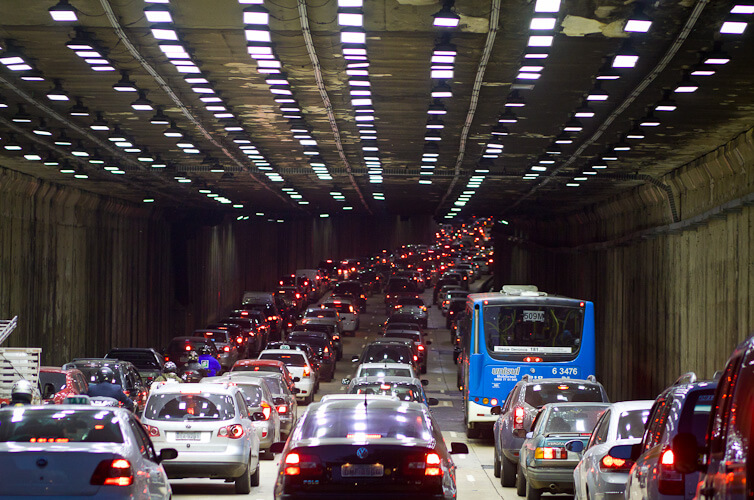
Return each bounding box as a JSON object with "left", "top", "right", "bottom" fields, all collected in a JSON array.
[{"left": 610, "top": 373, "right": 717, "bottom": 500}]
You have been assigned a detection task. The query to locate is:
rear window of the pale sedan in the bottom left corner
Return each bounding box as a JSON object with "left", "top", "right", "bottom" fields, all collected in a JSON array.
[{"left": 0, "top": 408, "right": 123, "bottom": 445}]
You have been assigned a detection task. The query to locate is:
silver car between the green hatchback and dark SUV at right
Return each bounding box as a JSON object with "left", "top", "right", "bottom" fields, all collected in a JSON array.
[{"left": 566, "top": 400, "right": 654, "bottom": 500}]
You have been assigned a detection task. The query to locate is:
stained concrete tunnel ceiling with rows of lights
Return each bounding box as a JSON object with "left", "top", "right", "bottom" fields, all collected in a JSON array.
[{"left": 0, "top": 0, "right": 754, "bottom": 220}]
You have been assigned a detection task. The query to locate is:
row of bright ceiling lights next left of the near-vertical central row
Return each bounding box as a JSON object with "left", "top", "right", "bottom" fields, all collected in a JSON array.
[{"left": 239, "top": 0, "right": 332, "bottom": 204}]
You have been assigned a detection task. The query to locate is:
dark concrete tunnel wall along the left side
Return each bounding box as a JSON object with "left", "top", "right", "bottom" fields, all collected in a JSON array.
[{"left": 0, "top": 167, "right": 436, "bottom": 365}]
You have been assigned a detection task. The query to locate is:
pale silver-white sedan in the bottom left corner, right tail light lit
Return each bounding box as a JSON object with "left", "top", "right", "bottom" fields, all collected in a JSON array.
[{"left": 0, "top": 404, "right": 177, "bottom": 500}]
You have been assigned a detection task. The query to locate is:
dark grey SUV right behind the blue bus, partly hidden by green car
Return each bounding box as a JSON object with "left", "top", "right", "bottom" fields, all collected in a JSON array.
[{"left": 491, "top": 375, "right": 609, "bottom": 487}]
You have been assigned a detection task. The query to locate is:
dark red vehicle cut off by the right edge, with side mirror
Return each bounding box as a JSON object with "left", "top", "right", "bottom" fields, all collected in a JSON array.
[{"left": 673, "top": 337, "right": 754, "bottom": 500}]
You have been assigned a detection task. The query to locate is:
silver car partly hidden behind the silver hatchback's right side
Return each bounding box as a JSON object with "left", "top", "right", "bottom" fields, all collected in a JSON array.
[{"left": 202, "top": 372, "right": 280, "bottom": 458}]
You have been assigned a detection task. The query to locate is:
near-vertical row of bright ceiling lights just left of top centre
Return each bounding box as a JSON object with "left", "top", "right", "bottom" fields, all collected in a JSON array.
[{"left": 338, "top": 0, "right": 385, "bottom": 201}]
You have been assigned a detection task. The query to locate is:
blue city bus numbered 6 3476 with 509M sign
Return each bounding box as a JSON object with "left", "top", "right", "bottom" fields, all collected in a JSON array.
[{"left": 458, "top": 285, "right": 595, "bottom": 437}]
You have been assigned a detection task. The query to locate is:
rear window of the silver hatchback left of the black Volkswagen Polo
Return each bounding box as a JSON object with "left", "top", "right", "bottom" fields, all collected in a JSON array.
[{"left": 144, "top": 392, "right": 236, "bottom": 420}]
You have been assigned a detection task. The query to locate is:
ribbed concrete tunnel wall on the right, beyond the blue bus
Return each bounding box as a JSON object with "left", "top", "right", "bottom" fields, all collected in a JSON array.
[{"left": 495, "top": 129, "right": 754, "bottom": 400}]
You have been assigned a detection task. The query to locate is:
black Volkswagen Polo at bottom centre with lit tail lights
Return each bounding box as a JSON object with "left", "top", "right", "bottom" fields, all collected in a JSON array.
[{"left": 272, "top": 394, "right": 468, "bottom": 500}]
